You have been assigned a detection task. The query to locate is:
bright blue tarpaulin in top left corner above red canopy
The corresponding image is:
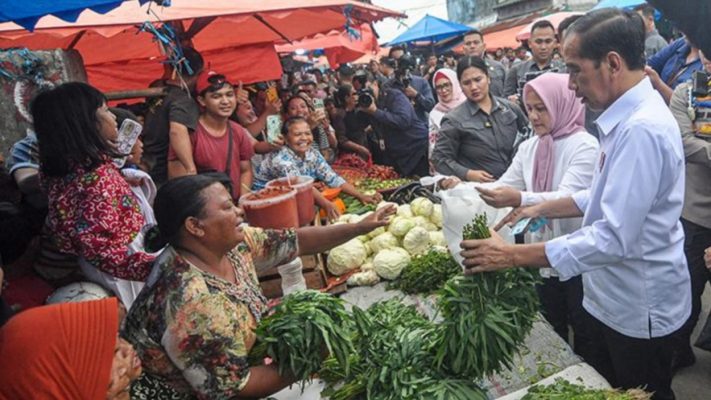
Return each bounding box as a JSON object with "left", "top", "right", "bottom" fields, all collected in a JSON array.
[{"left": 0, "top": 0, "right": 155, "bottom": 31}]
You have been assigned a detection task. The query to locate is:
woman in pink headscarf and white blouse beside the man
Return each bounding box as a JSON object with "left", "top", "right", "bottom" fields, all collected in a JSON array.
[{"left": 443, "top": 73, "right": 599, "bottom": 357}]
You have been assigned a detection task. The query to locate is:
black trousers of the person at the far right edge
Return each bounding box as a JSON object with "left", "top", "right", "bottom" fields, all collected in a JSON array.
[{"left": 677, "top": 218, "right": 711, "bottom": 353}]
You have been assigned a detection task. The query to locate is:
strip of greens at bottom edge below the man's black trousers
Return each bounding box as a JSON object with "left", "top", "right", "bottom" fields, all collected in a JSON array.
[{"left": 521, "top": 378, "right": 652, "bottom": 400}]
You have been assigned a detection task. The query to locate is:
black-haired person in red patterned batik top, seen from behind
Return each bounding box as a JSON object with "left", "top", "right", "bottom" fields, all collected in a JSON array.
[{"left": 31, "top": 82, "right": 154, "bottom": 307}]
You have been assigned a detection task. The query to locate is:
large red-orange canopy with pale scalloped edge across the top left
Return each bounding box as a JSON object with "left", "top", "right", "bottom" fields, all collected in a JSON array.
[{"left": 0, "top": 0, "right": 402, "bottom": 91}]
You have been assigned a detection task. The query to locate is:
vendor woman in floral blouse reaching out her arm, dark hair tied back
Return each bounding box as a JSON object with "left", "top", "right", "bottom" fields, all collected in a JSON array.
[{"left": 123, "top": 175, "right": 395, "bottom": 399}]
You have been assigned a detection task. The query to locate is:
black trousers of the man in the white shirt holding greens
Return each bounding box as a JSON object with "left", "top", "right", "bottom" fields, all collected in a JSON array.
[{"left": 585, "top": 312, "right": 678, "bottom": 400}]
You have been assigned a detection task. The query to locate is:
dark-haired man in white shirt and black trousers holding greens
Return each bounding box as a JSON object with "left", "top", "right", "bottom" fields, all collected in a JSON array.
[{"left": 462, "top": 9, "right": 691, "bottom": 400}]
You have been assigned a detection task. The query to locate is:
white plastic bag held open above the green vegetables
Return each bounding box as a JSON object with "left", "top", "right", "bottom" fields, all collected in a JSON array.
[{"left": 437, "top": 183, "right": 514, "bottom": 268}]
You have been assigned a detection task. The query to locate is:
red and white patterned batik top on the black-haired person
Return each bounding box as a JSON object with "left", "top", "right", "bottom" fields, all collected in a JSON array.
[{"left": 45, "top": 160, "right": 155, "bottom": 281}]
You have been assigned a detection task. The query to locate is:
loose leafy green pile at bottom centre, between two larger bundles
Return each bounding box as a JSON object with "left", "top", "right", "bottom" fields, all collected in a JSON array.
[{"left": 320, "top": 299, "right": 486, "bottom": 400}]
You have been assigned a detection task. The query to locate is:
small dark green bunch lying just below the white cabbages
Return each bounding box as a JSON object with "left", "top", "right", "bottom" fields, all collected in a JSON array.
[{"left": 391, "top": 249, "right": 462, "bottom": 294}]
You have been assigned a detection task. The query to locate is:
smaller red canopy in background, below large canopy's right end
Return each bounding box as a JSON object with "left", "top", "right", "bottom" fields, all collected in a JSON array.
[{"left": 276, "top": 24, "right": 380, "bottom": 68}]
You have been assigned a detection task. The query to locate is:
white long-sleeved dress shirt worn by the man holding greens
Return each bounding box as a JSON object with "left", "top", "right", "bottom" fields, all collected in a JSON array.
[{"left": 546, "top": 78, "right": 691, "bottom": 339}]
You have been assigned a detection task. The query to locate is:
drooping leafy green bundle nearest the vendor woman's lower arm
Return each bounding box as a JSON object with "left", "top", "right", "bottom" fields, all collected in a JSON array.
[{"left": 250, "top": 290, "right": 354, "bottom": 388}]
